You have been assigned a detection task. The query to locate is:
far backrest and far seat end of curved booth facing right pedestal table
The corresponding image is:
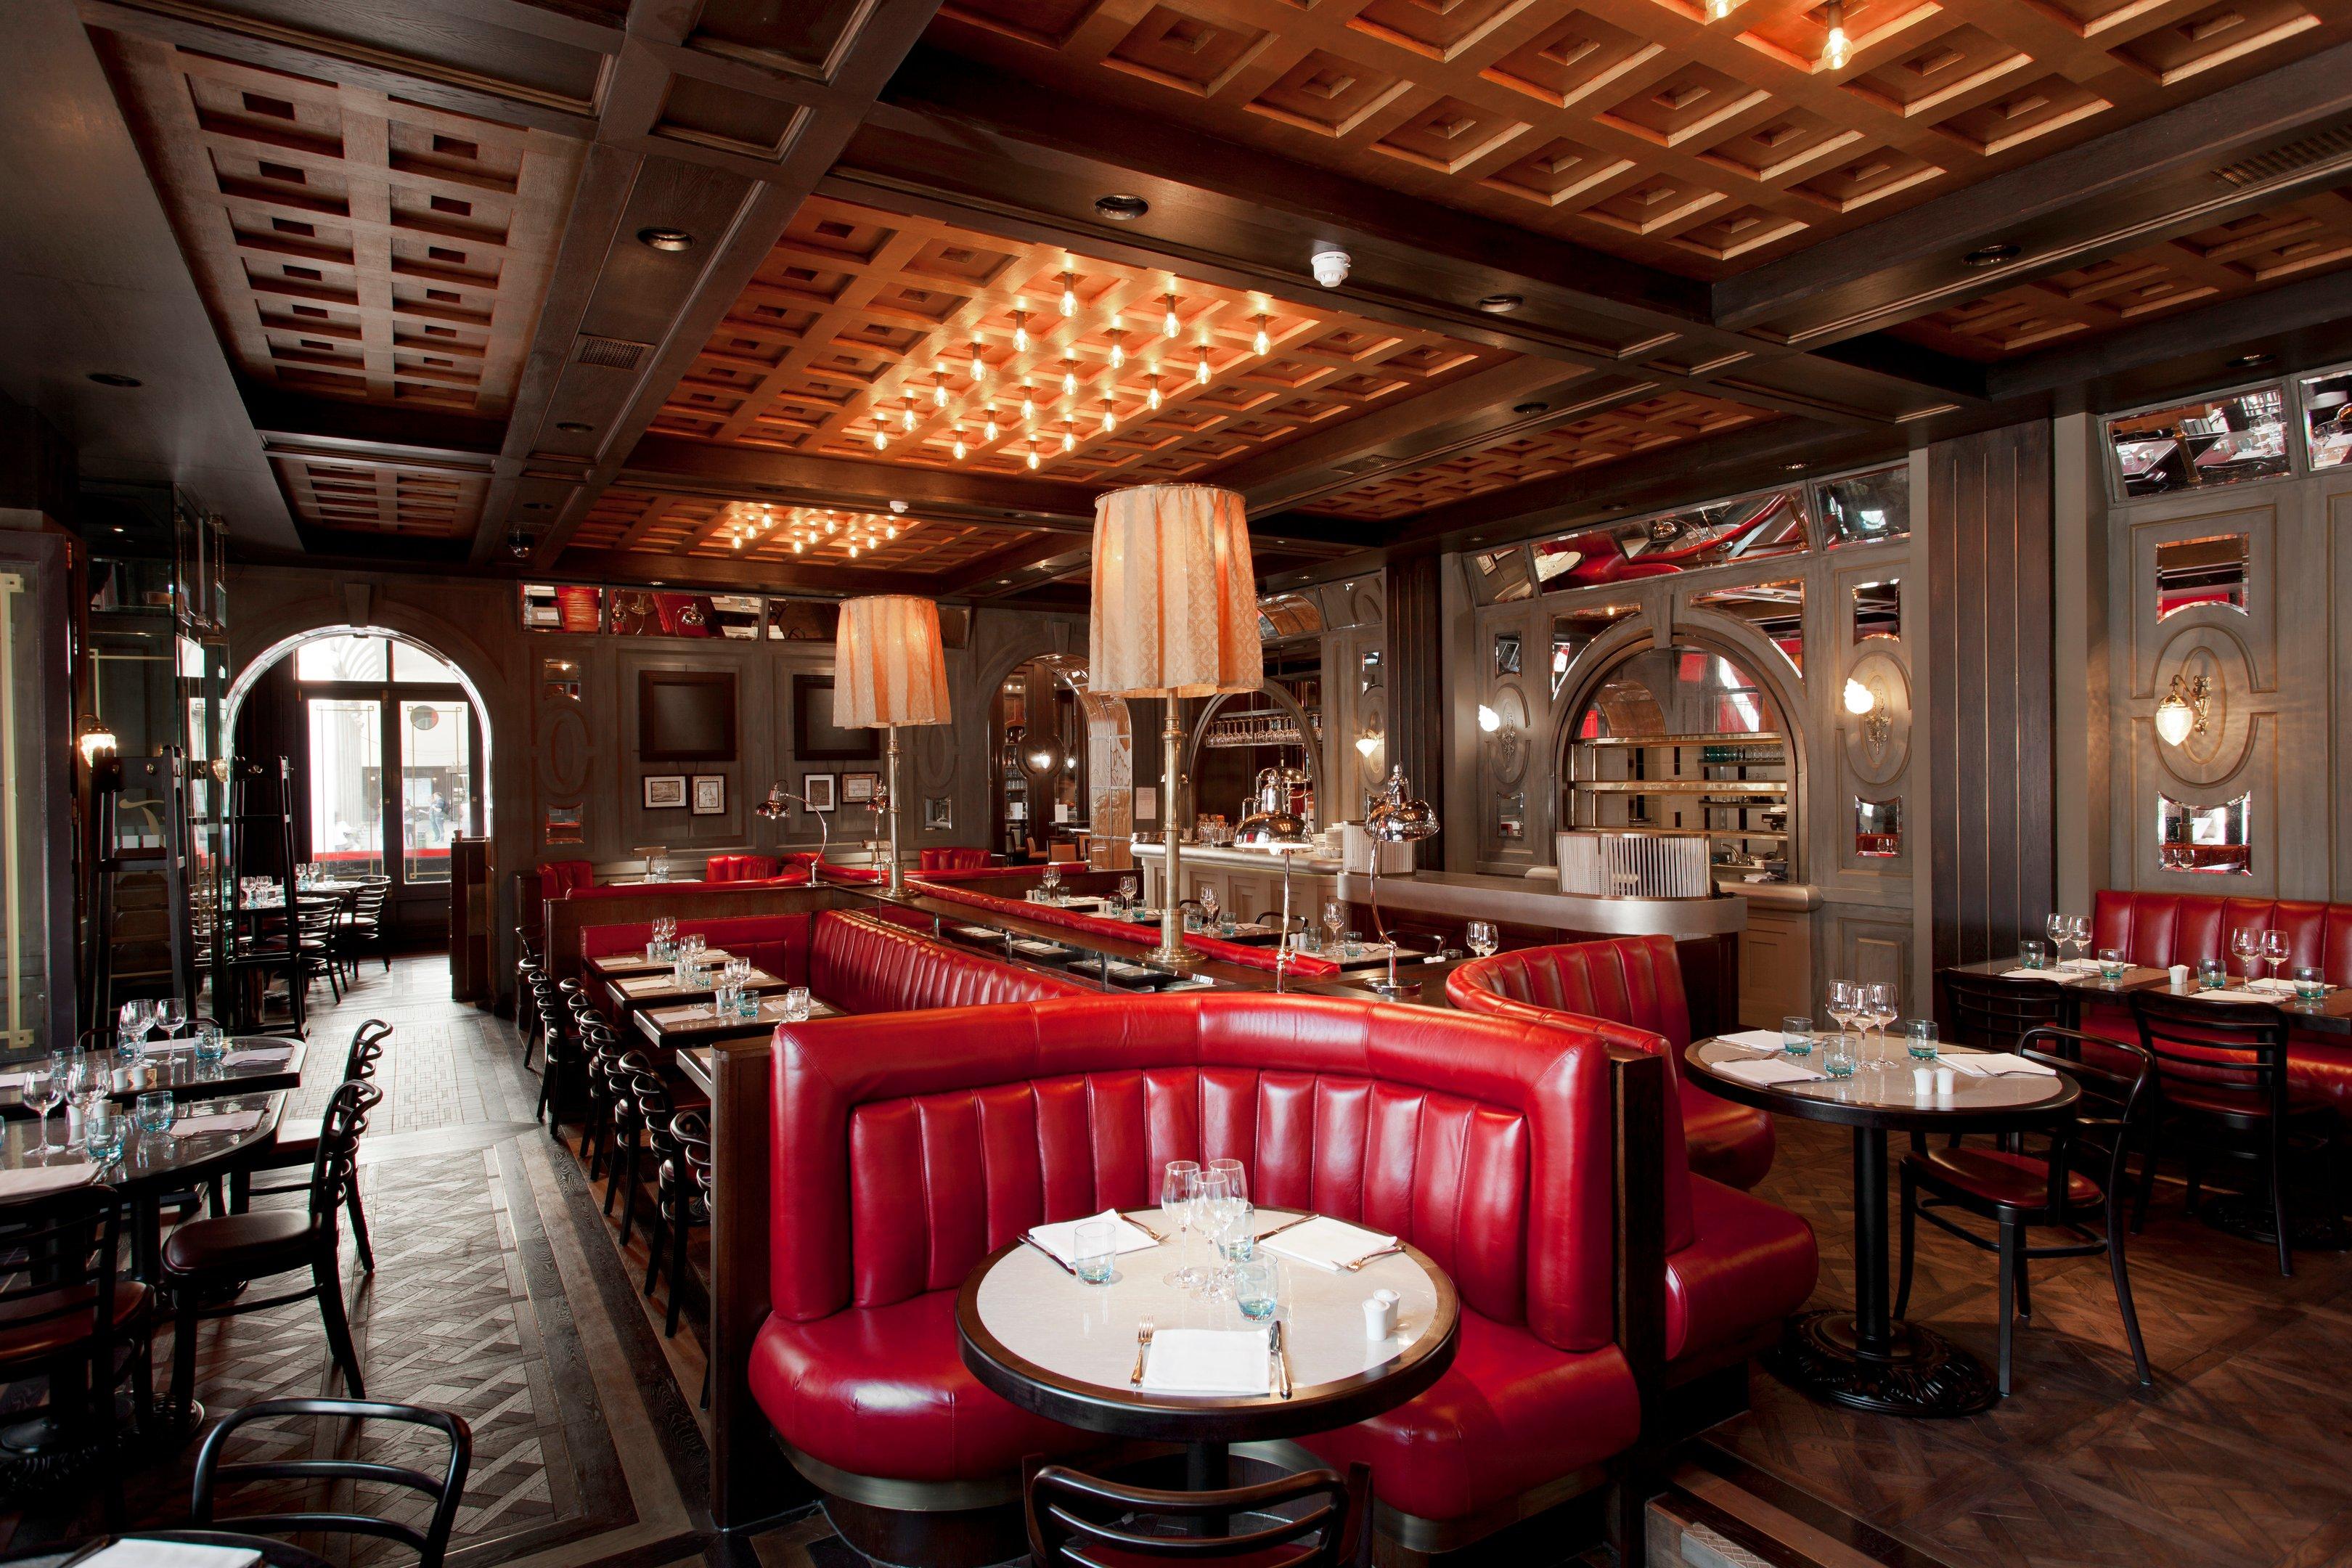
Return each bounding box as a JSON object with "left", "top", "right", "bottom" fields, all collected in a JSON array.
[{"left": 1447, "top": 936, "right": 1773, "bottom": 1192}]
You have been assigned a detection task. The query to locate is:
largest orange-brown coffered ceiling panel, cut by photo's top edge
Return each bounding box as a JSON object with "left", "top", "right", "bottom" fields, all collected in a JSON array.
[{"left": 931, "top": 0, "right": 2352, "bottom": 277}]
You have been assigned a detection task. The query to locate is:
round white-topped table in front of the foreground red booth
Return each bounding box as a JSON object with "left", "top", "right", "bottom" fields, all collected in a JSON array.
[{"left": 955, "top": 1209, "right": 1461, "bottom": 1490}]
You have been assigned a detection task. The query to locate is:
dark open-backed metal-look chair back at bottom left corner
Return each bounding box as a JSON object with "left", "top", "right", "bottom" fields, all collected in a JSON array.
[{"left": 188, "top": 1399, "right": 473, "bottom": 1568}]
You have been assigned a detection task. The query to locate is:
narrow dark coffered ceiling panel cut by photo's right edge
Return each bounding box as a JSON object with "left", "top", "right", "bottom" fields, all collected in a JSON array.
[{"left": 1893, "top": 190, "right": 2352, "bottom": 359}]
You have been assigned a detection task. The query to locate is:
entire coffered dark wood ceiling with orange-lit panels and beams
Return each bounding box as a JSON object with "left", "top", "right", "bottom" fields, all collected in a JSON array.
[{"left": 38, "top": 0, "right": 2352, "bottom": 602}]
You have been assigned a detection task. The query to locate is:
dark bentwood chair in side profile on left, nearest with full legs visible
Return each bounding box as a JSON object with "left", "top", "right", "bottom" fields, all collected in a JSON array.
[{"left": 163, "top": 1084, "right": 383, "bottom": 1408}]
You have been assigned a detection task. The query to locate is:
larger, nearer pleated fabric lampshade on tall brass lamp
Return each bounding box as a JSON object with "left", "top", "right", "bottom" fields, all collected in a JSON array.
[{"left": 1087, "top": 484, "right": 1265, "bottom": 696}]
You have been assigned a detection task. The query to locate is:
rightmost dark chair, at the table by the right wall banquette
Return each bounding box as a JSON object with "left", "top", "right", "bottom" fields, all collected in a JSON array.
[{"left": 2131, "top": 992, "right": 2343, "bottom": 1274}]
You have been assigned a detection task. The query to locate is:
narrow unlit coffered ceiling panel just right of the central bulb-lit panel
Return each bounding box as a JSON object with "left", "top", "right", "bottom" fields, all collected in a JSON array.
[{"left": 1298, "top": 393, "right": 1771, "bottom": 522}]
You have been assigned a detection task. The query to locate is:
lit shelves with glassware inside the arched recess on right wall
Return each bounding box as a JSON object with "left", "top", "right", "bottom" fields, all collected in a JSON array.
[{"left": 1564, "top": 731, "right": 1790, "bottom": 881}]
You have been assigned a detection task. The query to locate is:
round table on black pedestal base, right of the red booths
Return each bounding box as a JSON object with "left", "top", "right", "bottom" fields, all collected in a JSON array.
[{"left": 1682, "top": 1039, "right": 2081, "bottom": 1416}]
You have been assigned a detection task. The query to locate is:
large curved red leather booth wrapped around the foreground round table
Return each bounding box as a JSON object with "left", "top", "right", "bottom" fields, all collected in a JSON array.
[{"left": 751, "top": 992, "right": 1639, "bottom": 1519}]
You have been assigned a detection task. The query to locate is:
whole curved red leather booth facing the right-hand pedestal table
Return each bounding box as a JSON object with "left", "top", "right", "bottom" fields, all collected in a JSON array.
[{"left": 1447, "top": 936, "right": 1821, "bottom": 1368}]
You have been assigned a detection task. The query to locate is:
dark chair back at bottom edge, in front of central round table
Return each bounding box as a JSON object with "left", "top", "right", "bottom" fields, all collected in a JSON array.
[{"left": 1021, "top": 1460, "right": 1371, "bottom": 1568}]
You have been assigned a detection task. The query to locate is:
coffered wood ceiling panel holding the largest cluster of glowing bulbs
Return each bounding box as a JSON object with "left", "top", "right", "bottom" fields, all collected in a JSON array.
[{"left": 654, "top": 197, "right": 1510, "bottom": 484}]
